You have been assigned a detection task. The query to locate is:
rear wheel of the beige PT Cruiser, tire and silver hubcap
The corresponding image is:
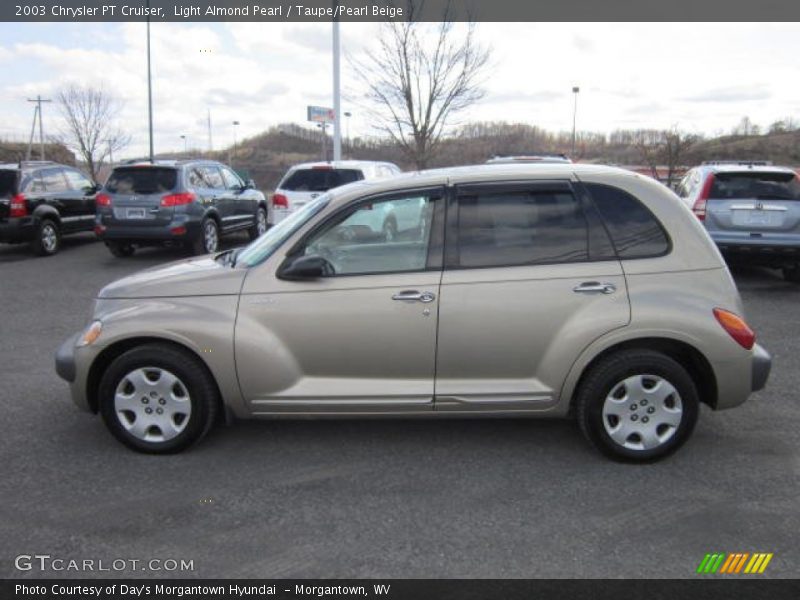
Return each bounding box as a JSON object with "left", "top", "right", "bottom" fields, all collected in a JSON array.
[{"left": 576, "top": 350, "right": 699, "bottom": 462}]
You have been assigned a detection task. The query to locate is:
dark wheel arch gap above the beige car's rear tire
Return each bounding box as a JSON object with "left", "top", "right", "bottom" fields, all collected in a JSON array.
[{"left": 564, "top": 336, "right": 718, "bottom": 415}]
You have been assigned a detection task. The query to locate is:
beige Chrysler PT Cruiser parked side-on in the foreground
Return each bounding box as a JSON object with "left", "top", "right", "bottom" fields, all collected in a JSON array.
[{"left": 56, "top": 164, "right": 771, "bottom": 461}]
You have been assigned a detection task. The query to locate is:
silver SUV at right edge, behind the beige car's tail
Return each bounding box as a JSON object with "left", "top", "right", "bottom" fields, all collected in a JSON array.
[{"left": 677, "top": 161, "right": 800, "bottom": 283}]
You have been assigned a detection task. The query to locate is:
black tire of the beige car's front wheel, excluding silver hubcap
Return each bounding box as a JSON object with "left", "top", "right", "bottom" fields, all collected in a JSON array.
[{"left": 98, "top": 343, "right": 220, "bottom": 454}]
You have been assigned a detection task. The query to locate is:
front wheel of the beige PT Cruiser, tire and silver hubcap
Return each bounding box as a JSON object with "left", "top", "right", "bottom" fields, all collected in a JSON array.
[{"left": 98, "top": 344, "right": 219, "bottom": 454}]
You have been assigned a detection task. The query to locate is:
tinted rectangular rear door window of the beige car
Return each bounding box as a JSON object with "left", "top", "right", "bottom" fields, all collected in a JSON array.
[{"left": 458, "top": 190, "right": 589, "bottom": 268}]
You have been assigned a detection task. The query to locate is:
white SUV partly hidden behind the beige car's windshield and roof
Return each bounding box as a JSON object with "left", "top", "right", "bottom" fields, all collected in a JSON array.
[{"left": 270, "top": 160, "right": 401, "bottom": 224}]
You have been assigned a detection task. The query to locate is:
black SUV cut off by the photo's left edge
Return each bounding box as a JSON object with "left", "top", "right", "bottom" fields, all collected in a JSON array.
[{"left": 0, "top": 161, "right": 100, "bottom": 256}]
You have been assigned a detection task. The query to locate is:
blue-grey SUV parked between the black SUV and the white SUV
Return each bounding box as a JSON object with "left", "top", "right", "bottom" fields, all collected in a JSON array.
[{"left": 95, "top": 159, "right": 268, "bottom": 257}]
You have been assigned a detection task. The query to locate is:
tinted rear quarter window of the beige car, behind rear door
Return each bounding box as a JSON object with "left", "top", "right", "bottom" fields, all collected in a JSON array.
[{"left": 585, "top": 183, "right": 670, "bottom": 259}]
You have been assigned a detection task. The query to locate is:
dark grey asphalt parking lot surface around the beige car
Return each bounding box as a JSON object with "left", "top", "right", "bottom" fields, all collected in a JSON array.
[{"left": 0, "top": 234, "right": 800, "bottom": 578}]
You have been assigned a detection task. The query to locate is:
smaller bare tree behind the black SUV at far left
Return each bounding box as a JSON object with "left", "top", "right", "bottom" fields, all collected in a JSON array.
[{"left": 58, "top": 85, "right": 130, "bottom": 179}]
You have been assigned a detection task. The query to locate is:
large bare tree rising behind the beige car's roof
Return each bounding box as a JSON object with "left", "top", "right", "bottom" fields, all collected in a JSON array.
[{"left": 350, "top": 0, "right": 489, "bottom": 169}]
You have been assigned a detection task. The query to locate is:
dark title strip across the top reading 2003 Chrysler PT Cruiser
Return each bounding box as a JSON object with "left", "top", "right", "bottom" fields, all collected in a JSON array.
[{"left": 0, "top": 0, "right": 800, "bottom": 22}]
